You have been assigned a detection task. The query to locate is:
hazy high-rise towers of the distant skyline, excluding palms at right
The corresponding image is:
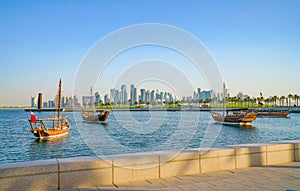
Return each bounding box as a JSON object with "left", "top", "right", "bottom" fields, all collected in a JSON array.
[{"left": 30, "top": 84, "right": 211, "bottom": 107}]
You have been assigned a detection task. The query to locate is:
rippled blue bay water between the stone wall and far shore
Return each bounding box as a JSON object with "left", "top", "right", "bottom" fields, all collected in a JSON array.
[{"left": 0, "top": 109, "right": 300, "bottom": 163}]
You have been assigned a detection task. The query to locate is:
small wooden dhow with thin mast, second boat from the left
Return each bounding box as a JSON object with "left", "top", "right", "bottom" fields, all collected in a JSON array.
[{"left": 81, "top": 87, "right": 110, "bottom": 122}]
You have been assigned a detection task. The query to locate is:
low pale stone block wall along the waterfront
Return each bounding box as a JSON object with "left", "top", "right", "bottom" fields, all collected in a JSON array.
[{"left": 0, "top": 140, "right": 300, "bottom": 190}]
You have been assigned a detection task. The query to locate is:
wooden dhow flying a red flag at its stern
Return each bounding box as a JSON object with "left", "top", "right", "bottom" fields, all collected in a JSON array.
[{"left": 28, "top": 80, "right": 70, "bottom": 139}]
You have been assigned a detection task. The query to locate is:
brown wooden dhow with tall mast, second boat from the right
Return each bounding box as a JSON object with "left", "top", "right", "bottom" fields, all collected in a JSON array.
[{"left": 210, "top": 83, "right": 257, "bottom": 125}]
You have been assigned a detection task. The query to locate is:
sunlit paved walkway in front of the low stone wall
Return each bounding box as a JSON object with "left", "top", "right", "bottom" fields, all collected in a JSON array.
[{"left": 59, "top": 162, "right": 300, "bottom": 191}]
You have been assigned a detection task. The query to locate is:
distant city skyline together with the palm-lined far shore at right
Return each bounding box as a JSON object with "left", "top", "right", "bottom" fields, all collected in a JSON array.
[{"left": 27, "top": 84, "right": 299, "bottom": 108}]
